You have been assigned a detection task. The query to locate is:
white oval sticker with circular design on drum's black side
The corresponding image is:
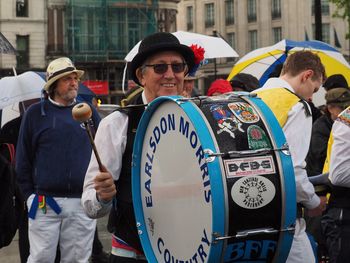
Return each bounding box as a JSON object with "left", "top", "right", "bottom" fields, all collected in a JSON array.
[{"left": 231, "top": 176, "right": 276, "bottom": 209}]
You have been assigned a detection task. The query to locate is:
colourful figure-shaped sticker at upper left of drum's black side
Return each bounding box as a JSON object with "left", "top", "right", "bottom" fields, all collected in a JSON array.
[{"left": 210, "top": 105, "right": 244, "bottom": 138}]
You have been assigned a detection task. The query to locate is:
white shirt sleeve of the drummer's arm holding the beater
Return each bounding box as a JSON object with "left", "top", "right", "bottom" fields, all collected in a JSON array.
[{"left": 82, "top": 111, "right": 128, "bottom": 218}]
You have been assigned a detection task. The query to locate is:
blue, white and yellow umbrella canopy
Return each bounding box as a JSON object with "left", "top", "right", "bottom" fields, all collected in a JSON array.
[{"left": 227, "top": 39, "right": 350, "bottom": 86}]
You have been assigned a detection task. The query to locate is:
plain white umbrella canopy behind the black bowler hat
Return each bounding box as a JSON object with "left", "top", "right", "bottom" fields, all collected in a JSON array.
[{"left": 124, "top": 31, "right": 238, "bottom": 62}]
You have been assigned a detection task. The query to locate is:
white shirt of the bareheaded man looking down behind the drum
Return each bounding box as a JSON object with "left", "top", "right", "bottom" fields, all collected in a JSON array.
[{"left": 258, "top": 78, "right": 320, "bottom": 209}]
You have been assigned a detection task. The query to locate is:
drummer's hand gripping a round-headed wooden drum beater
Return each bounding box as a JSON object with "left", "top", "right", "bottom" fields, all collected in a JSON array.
[{"left": 72, "top": 103, "right": 116, "bottom": 202}]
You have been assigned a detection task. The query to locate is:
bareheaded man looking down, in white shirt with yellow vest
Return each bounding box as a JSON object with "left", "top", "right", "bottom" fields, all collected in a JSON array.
[{"left": 254, "top": 51, "right": 326, "bottom": 263}]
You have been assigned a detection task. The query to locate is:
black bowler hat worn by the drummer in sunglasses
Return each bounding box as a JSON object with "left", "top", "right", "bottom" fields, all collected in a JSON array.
[{"left": 130, "top": 32, "right": 194, "bottom": 85}]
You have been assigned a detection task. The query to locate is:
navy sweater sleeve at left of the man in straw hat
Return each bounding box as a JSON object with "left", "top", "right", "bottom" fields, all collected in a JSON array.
[{"left": 16, "top": 111, "right": 35, "bottom": 199}]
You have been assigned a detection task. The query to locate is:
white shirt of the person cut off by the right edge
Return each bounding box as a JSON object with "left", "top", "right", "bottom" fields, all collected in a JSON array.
[{"left": 329, "top": 112, "right": 350, "bottom": 187}]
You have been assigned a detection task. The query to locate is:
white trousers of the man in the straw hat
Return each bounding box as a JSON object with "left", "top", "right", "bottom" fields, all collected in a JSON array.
[{"left": 27, "top": 195, "right": 96, "bottom": 263}]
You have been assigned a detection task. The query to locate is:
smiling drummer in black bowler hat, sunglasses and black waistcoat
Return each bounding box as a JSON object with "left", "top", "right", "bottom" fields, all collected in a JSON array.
[{"left": 82, "top": 33, "right": 194, "bottom": 262}]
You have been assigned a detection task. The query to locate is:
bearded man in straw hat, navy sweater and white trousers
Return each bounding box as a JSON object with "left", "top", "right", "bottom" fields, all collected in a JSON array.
[{"left": 16, "top": 57, "right": 100, "bottom": 262}]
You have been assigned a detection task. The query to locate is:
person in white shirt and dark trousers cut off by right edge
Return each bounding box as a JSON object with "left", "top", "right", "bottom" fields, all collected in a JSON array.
[{"left": 321, "top": 106, "right": 350, "bottom": 262}]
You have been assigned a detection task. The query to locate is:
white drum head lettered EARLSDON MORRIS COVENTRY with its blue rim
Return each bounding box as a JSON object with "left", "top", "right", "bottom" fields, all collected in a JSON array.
[{"left": 132, "top": 97, "right": 225, "bottom": 262}]
